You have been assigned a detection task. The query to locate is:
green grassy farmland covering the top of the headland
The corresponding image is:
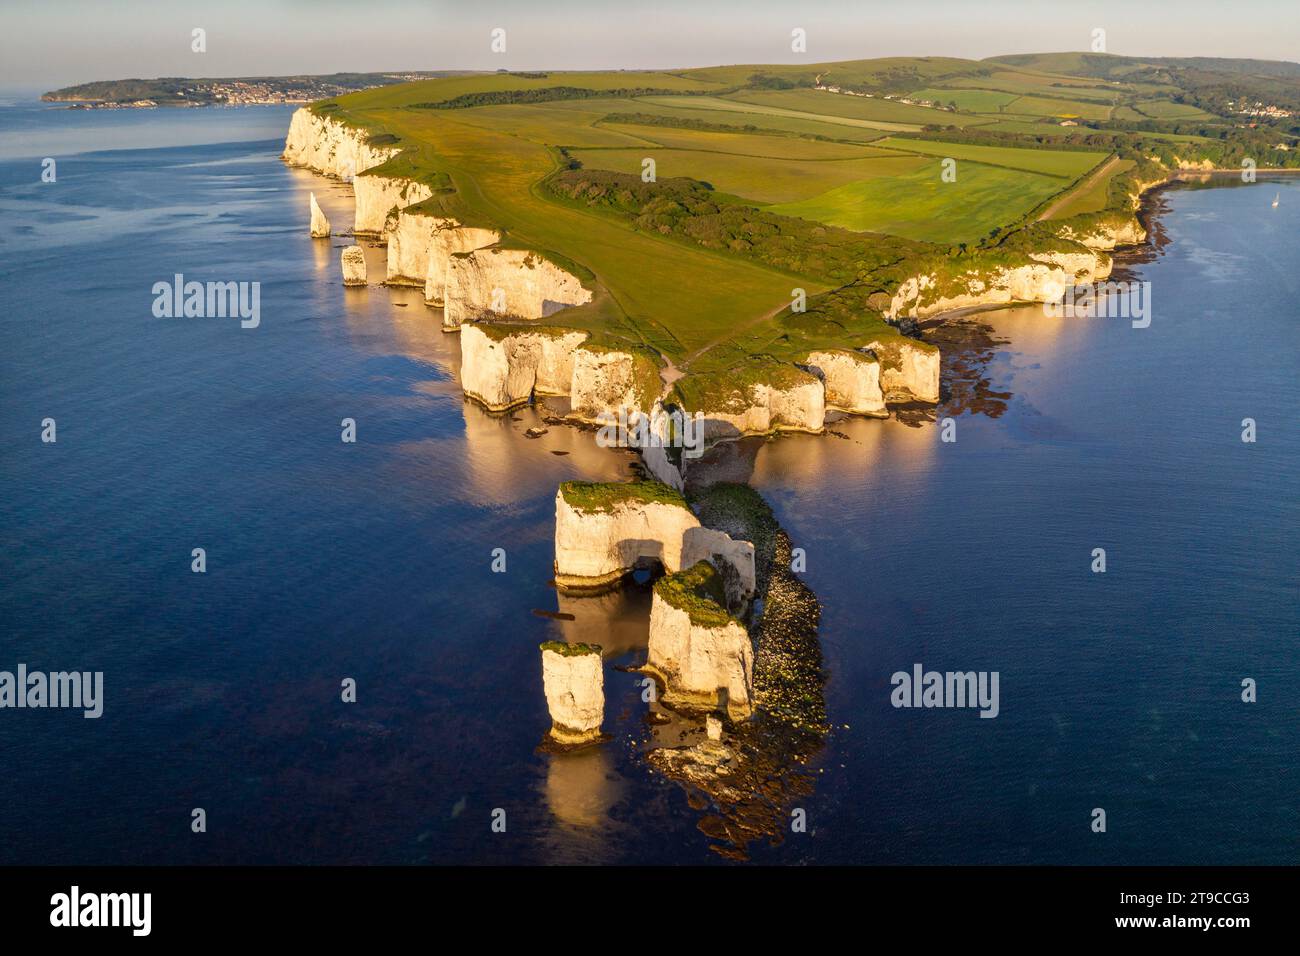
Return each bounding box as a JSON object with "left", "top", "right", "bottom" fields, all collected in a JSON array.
[{"left": 301, "top": 55, "right": 1287, "bottom": 382}]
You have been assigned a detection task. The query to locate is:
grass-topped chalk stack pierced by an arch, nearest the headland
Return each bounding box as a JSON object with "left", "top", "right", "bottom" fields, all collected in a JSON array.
[{"left": 555, "top": 481, "right": 754, "bottom": 598}]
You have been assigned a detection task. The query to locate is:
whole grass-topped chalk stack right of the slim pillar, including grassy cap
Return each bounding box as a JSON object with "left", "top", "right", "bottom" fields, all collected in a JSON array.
[{"left": 646, "top": 562, "right": 754, "bottom": 721}]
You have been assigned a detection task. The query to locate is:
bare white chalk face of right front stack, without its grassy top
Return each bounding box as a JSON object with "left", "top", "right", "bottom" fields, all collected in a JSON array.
[{"left": 646, "top": 589, "right": 754, "bottom": 721}]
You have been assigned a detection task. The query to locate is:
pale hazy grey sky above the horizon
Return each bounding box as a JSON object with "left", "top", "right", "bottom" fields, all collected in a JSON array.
[{"left": 0, "top": 0, "right": 1300, "bottom": 90}]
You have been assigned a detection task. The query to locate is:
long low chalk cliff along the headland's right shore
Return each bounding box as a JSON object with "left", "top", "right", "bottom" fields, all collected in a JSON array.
[{"left": 884, "top": 252, "right": 1110, "bottom": 319}]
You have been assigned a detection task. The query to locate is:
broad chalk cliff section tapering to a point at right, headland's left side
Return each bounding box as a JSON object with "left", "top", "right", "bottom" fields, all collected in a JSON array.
[{"left": 444, "top": 248, "right": 592, "bottom": 328}]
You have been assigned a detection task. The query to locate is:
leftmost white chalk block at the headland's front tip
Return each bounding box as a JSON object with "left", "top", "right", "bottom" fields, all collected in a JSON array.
[{"left": 460, "top": 324, "right": 586, "bottom": 411}]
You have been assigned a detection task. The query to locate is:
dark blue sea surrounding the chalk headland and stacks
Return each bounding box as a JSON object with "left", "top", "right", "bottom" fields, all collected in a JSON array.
[{"left": 0, "top": 107, "right": 1300, "bottom": 864}]
